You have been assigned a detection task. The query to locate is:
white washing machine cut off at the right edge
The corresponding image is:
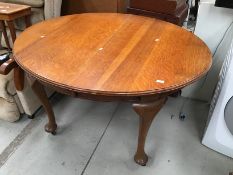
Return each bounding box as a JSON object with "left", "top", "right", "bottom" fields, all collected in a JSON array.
[{"left": 202, "top": 24, "right": 233, "bottom": 158}]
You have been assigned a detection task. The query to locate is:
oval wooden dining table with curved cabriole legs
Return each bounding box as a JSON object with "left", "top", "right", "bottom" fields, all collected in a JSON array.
[{"left": 13, "top": 13, "right": 212, "bottom": 165}]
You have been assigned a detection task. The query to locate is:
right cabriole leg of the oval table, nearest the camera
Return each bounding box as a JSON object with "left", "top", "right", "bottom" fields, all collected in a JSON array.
[{"left": 133, "top": 96, "right": 167, "bottom": 166}]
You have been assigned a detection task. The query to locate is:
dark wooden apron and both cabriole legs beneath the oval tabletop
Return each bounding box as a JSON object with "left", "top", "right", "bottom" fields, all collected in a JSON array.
[{"left": 28, "top": 75, "right": 177, "bottom": 166}]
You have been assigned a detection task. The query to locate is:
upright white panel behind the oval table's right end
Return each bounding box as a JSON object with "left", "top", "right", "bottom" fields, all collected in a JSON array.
[{"left": 195, "top": 0, "right": 233, "bottom": 53}]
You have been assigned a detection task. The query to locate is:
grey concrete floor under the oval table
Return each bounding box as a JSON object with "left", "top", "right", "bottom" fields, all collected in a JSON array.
[{"left": 0, "top": 95, "right": 233, "bottom": 175}]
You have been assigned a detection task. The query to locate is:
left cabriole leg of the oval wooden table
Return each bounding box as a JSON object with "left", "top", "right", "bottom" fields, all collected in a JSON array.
[{"left": 28, "top": 76, "right": 57, "bottom": 135}]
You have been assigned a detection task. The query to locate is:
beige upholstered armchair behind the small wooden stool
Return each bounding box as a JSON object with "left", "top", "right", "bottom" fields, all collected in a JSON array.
[{"left": 0, "top": 0, "right": 61, "bottom": 122}]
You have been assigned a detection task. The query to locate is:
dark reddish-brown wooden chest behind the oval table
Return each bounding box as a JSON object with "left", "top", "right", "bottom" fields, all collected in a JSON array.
[{"left": 127, "top": 0, "right": 188, "bottom": 26}]
